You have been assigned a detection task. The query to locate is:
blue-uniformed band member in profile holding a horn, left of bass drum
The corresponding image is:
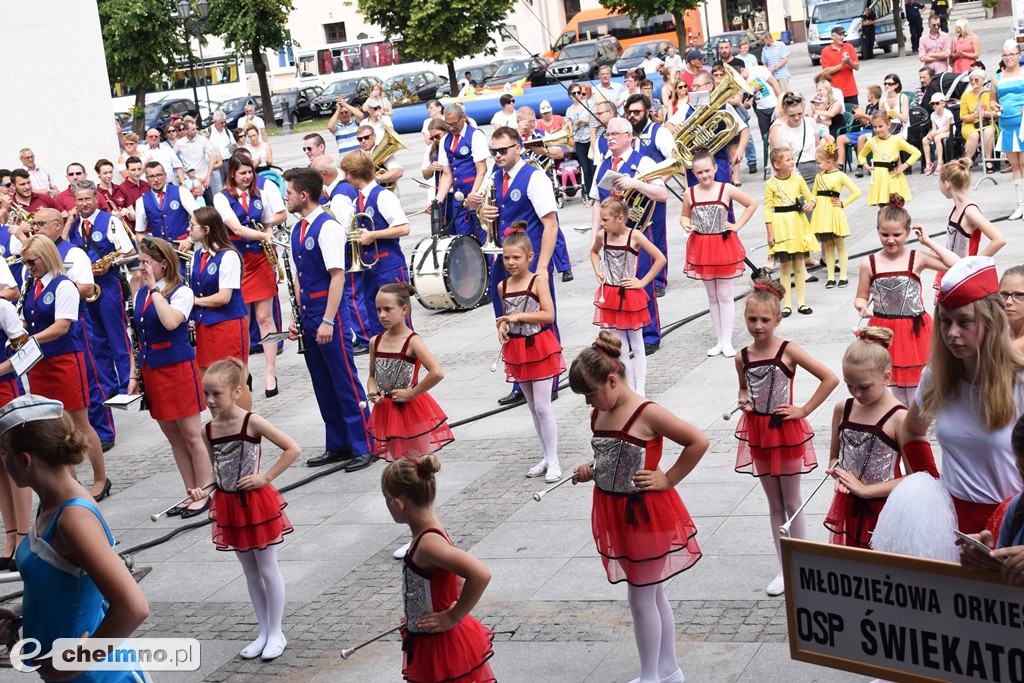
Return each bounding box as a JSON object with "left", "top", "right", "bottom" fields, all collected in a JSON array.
[{"left": 341, "top": 150, "right": 409, "bottom": 346}]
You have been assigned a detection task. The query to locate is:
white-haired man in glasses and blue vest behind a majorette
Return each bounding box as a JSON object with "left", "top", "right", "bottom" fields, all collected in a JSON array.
[{"left": 590, "top": 118, "right": 669, "bottom": 355}]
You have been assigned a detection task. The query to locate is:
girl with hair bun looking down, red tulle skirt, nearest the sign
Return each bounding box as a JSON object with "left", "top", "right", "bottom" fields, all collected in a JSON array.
[{"left": 569, "top": 331, "right": 708, "bottom": 683}]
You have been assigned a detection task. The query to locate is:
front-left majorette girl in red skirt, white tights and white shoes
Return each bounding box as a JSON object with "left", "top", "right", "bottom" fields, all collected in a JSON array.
[{"left": 189, "top": 358, "right": 300, "bottom": 660}]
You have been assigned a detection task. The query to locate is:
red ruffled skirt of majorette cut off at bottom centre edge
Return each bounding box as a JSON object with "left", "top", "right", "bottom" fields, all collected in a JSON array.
[{"left": 401, "top": 614, "right": 498, "bottom": 683}]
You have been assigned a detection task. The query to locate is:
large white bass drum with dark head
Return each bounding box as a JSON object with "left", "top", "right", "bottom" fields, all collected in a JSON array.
[{"left": 409, "top": 234, "right": 489, "bottom": 310}]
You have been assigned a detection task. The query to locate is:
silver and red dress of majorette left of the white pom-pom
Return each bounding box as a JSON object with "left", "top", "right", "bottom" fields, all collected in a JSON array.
[{"left": 824, "top": 398, "right": 906, "bottom": 549}]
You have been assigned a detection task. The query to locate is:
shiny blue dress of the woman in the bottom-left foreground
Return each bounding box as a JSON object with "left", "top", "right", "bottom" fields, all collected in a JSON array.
[{"left": 15, "top": 498, "right": 150, "bottom": 683}]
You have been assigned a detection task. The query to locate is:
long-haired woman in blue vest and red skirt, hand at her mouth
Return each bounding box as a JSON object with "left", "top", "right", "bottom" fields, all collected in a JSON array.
[{"left": 128, "top": 238, "right": 210, "bottom": 519}]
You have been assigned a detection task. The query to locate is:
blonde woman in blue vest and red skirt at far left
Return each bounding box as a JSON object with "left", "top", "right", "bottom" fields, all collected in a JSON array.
[{"left": 22, "top": 237, "right": 111, "bottom": 503}]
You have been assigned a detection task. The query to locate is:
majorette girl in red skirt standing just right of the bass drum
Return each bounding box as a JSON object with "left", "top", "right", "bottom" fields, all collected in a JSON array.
[{"left": 498, "top": 225, "right": 565, "bottom": 482}]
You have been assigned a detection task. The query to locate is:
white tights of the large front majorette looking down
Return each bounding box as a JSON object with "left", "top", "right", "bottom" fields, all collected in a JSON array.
[{"left": 627, "top": 584, "right": 679, "bottom": 683}]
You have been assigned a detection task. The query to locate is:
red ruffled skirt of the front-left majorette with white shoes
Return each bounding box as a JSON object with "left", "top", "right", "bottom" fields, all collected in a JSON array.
[{"left": 210, "top": 483, "right": 292, "bottom": 552}]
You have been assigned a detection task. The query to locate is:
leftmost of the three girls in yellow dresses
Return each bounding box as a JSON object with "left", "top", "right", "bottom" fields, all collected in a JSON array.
[{"left": 765, "top": 147, "right": 817, "bottom": 317}]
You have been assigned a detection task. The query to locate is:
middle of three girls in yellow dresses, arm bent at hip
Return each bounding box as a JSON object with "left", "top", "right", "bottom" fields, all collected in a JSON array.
[{"left": 811, "top": 142, "right": 860, "bottom": 290}]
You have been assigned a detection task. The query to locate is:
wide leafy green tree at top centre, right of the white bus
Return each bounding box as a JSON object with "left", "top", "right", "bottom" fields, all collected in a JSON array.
[{"left": 358, "top": 0, "right": 515, "bottom": 92}]
